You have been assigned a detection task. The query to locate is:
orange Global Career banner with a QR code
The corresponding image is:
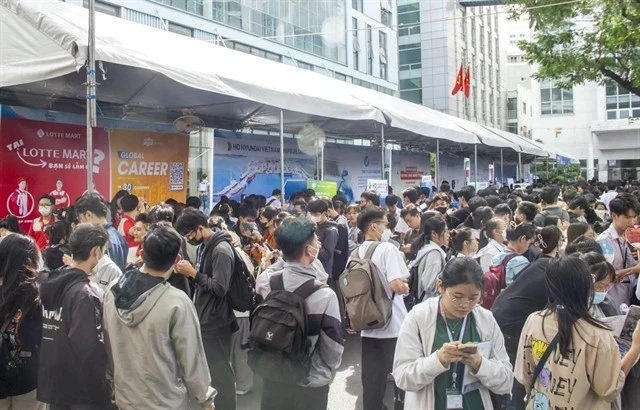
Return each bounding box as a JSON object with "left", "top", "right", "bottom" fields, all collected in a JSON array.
[{"left": 110, "top": 130, "right": 189, "bottom": 205}]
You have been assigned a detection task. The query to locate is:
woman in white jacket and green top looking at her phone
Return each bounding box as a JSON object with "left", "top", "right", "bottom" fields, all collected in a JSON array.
[{"left": 393, "top": 258, "right": 513, "bottom": 410}]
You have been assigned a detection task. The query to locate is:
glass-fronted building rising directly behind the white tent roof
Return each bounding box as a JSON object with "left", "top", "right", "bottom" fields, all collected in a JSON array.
[{"left": 66, "top": 0, "right": 398, "bottom": 94}]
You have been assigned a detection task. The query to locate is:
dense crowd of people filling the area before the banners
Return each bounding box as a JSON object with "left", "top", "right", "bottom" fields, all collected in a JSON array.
[{"left": 0, "top": 181, "right": 640, "bottom": 410}]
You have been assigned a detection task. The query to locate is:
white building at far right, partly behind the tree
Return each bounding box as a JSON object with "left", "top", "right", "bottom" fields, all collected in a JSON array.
[{"left": 500, "top": 10, "right": 640, "bottom": 181}]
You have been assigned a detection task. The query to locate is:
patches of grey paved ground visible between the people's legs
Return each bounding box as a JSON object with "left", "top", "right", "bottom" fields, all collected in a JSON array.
[{"left": 238, "top": 335, "right": 393, "bottom": 410}]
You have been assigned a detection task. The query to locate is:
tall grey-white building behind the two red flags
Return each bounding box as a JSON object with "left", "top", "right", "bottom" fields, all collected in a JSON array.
[{"left": 398, "top": 0, "right": 504, "bottom": 128}]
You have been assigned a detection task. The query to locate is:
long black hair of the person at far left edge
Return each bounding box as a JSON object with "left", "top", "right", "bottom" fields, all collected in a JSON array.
[{"left": 0, "top": 234, "right": 41, "bottom": 323}]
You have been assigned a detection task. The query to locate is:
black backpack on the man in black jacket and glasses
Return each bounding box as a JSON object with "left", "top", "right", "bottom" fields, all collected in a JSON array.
[{"left": 204, "top": 237, "right": 256, "bottom": 312}]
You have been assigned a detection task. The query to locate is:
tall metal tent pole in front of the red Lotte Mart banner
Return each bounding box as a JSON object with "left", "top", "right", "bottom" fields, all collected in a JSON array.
[{"left": 87, "top": 0, "right": 96, "bottom": 193}]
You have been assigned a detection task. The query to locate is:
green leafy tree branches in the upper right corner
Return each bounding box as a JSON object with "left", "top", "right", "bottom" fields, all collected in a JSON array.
[{"left": 506, "top": 0, "right": 640, "bottom": 96}]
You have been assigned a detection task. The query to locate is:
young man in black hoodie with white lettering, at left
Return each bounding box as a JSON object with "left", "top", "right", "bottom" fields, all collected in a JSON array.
[{"left": 38, "top": 224, "right": 111, "bottom": 410}]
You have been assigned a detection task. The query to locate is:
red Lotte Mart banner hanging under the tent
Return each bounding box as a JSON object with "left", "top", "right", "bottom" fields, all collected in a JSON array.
[{"left": 0, "top": 118, "right": 111, "bottom": 231}]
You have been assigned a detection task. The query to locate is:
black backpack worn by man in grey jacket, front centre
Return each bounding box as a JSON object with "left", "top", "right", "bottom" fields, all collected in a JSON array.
[{"left": 248, "top": 274, "right": 327, "bottom": 384}]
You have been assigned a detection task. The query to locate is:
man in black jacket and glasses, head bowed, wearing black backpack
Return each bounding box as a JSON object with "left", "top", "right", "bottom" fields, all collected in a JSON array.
[{"left": 176, "top": 208, "right": 239, "bottom": 410}]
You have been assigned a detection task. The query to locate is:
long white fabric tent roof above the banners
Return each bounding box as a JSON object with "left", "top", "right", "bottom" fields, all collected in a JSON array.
[{"left": 0, "top": 0, "right": 580, "bottom": 160}]
